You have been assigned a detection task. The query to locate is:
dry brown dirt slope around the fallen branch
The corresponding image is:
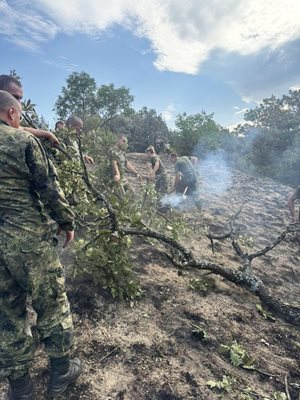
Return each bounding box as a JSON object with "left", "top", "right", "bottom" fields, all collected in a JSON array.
[{"left": 0, "top": 154, "right": 300, "bottom": 400}]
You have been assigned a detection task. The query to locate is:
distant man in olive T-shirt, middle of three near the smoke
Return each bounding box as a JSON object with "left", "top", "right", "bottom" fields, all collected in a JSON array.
[{"left": 146, "top": 146, "right": 168, "bottom": 195}]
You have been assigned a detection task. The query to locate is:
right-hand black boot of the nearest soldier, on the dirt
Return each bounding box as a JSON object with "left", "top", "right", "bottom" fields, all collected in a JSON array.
[{"left": 49, "top": 357, "right": 81, "bottom": 397}]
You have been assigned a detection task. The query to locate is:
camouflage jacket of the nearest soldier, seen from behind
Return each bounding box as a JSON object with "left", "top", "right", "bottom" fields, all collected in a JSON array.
[{"left": 0, "top": 123, "right": 74, "bottom": 235}]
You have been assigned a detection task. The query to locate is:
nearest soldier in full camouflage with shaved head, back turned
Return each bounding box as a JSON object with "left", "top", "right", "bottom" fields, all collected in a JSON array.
[{"left": 0, "top": 91, "right": 81, "bottom": 400}]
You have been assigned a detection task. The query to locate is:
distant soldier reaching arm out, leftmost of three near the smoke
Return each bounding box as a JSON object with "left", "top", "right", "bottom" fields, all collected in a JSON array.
[{"left": 111, "top": 134, "right": 142, "bottom": 197}]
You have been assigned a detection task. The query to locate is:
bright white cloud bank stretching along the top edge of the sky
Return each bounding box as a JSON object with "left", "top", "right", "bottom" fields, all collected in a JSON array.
[{"left": 0, "top": 0, "right": 300, "bottom": 74}]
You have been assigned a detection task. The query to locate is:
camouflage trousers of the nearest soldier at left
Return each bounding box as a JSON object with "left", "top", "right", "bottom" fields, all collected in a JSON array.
[{"left": 0, "top": 233, "right": 73, "bottom": 379}]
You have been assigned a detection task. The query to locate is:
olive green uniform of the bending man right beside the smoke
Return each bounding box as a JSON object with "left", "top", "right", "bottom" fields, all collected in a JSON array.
[{"left": 175, "top": 156, "right": 197, "bottom": 196}]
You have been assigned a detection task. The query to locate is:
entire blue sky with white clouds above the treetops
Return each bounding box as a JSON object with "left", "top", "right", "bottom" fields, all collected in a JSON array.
[{"left": 0, "top": 0, "right": 300, "bottom": 127}]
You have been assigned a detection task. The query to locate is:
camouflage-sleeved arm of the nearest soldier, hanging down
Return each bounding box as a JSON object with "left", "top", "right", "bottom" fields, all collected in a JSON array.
[{"left": 26, "top": 136, "right": 74, "bottom": 231}]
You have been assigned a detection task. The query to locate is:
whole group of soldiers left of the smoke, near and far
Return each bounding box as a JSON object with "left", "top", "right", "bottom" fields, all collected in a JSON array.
[{"left": 0, "top": 75, "right": 202, "bottom": 400}]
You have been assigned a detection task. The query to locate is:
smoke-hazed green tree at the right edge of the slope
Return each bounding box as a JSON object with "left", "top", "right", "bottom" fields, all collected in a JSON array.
[{"left": 241, "top": 90, "right": 300, "bottom": 185}]
